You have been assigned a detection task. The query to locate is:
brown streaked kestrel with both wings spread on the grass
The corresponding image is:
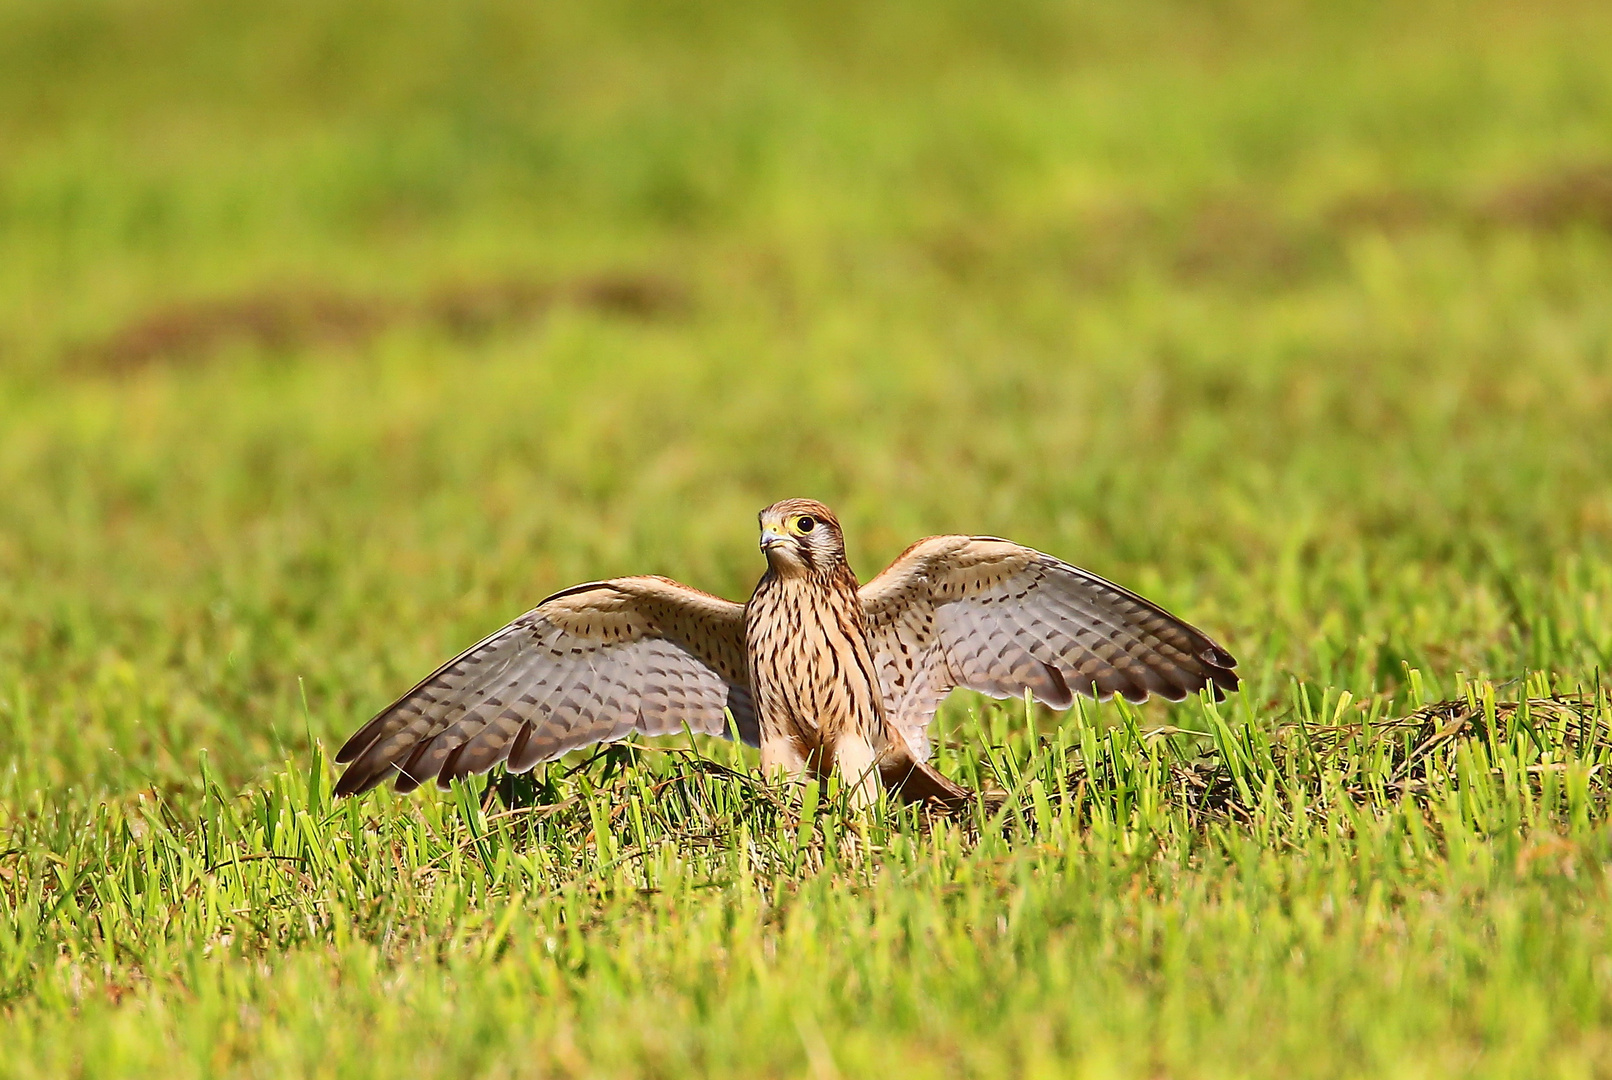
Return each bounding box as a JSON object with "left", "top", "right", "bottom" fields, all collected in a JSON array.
[{"left": 334, "top": 498, "right": 1238, "bottom": 809}]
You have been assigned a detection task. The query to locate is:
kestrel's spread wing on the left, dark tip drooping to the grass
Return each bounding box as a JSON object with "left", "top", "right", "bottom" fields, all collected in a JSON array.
[{"left": 335, "top": 577, "right": 758, "bottom": 795}]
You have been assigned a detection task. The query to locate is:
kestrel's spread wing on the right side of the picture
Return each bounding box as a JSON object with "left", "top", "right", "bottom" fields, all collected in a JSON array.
[{"left": 861, "top": 537, "right": 1238, "bottom": 761}]
